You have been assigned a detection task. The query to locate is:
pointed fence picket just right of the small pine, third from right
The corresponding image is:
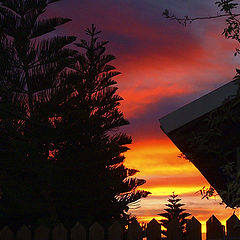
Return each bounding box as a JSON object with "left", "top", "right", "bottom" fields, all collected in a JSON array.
[{"left": 186, "top": 217, "right": 202, "bottom": 240}]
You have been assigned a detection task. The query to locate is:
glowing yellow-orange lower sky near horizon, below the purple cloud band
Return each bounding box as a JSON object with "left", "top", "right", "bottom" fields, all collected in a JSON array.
[{"left": 125, "top": 139, "right": 237, "bottom": 239}]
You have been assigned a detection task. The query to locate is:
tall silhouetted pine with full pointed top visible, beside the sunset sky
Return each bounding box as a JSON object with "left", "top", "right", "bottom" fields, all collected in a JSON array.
[{"left": 52, "top": 25, "right": 149, "bottom": 227}]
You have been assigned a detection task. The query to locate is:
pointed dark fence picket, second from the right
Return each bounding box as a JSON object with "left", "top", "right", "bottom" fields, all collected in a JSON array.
[{"left": 206, "top": 215, "right": 225, "bottom": 240}]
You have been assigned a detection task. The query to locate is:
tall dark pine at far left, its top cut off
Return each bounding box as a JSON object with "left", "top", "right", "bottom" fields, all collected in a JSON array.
[{"left": 0, "top": 0, "right": 76, "bottom": 226}]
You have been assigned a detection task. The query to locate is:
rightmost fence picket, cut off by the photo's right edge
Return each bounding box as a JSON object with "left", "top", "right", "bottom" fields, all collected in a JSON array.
[{"left": 226, "top": 214, "right": 240, "bottom": 240}]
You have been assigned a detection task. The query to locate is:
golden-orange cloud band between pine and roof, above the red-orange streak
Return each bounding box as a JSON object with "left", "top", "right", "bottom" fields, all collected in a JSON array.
[{"left": 125, "top": 138, "right": 201, "bottom": 177}]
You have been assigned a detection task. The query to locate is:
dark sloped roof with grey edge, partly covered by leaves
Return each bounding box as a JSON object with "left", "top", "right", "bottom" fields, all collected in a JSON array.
[{"left": 159, "top": 81, "right": 240, "bottom": 205}]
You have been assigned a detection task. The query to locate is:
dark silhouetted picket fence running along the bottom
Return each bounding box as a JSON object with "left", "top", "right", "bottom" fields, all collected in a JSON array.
[{"left": 0, "top": 214, "right": 240, "bottom": 240}]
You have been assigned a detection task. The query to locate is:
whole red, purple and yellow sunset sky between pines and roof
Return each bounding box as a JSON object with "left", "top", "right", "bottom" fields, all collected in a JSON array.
[{"left": 49, "top": 0, "right": 239, "bottom": 235}]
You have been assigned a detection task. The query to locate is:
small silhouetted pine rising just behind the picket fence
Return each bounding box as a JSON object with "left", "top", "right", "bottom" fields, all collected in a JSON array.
[{"left": 158, "top": 192, "right": 191, "bottom": 239}]
